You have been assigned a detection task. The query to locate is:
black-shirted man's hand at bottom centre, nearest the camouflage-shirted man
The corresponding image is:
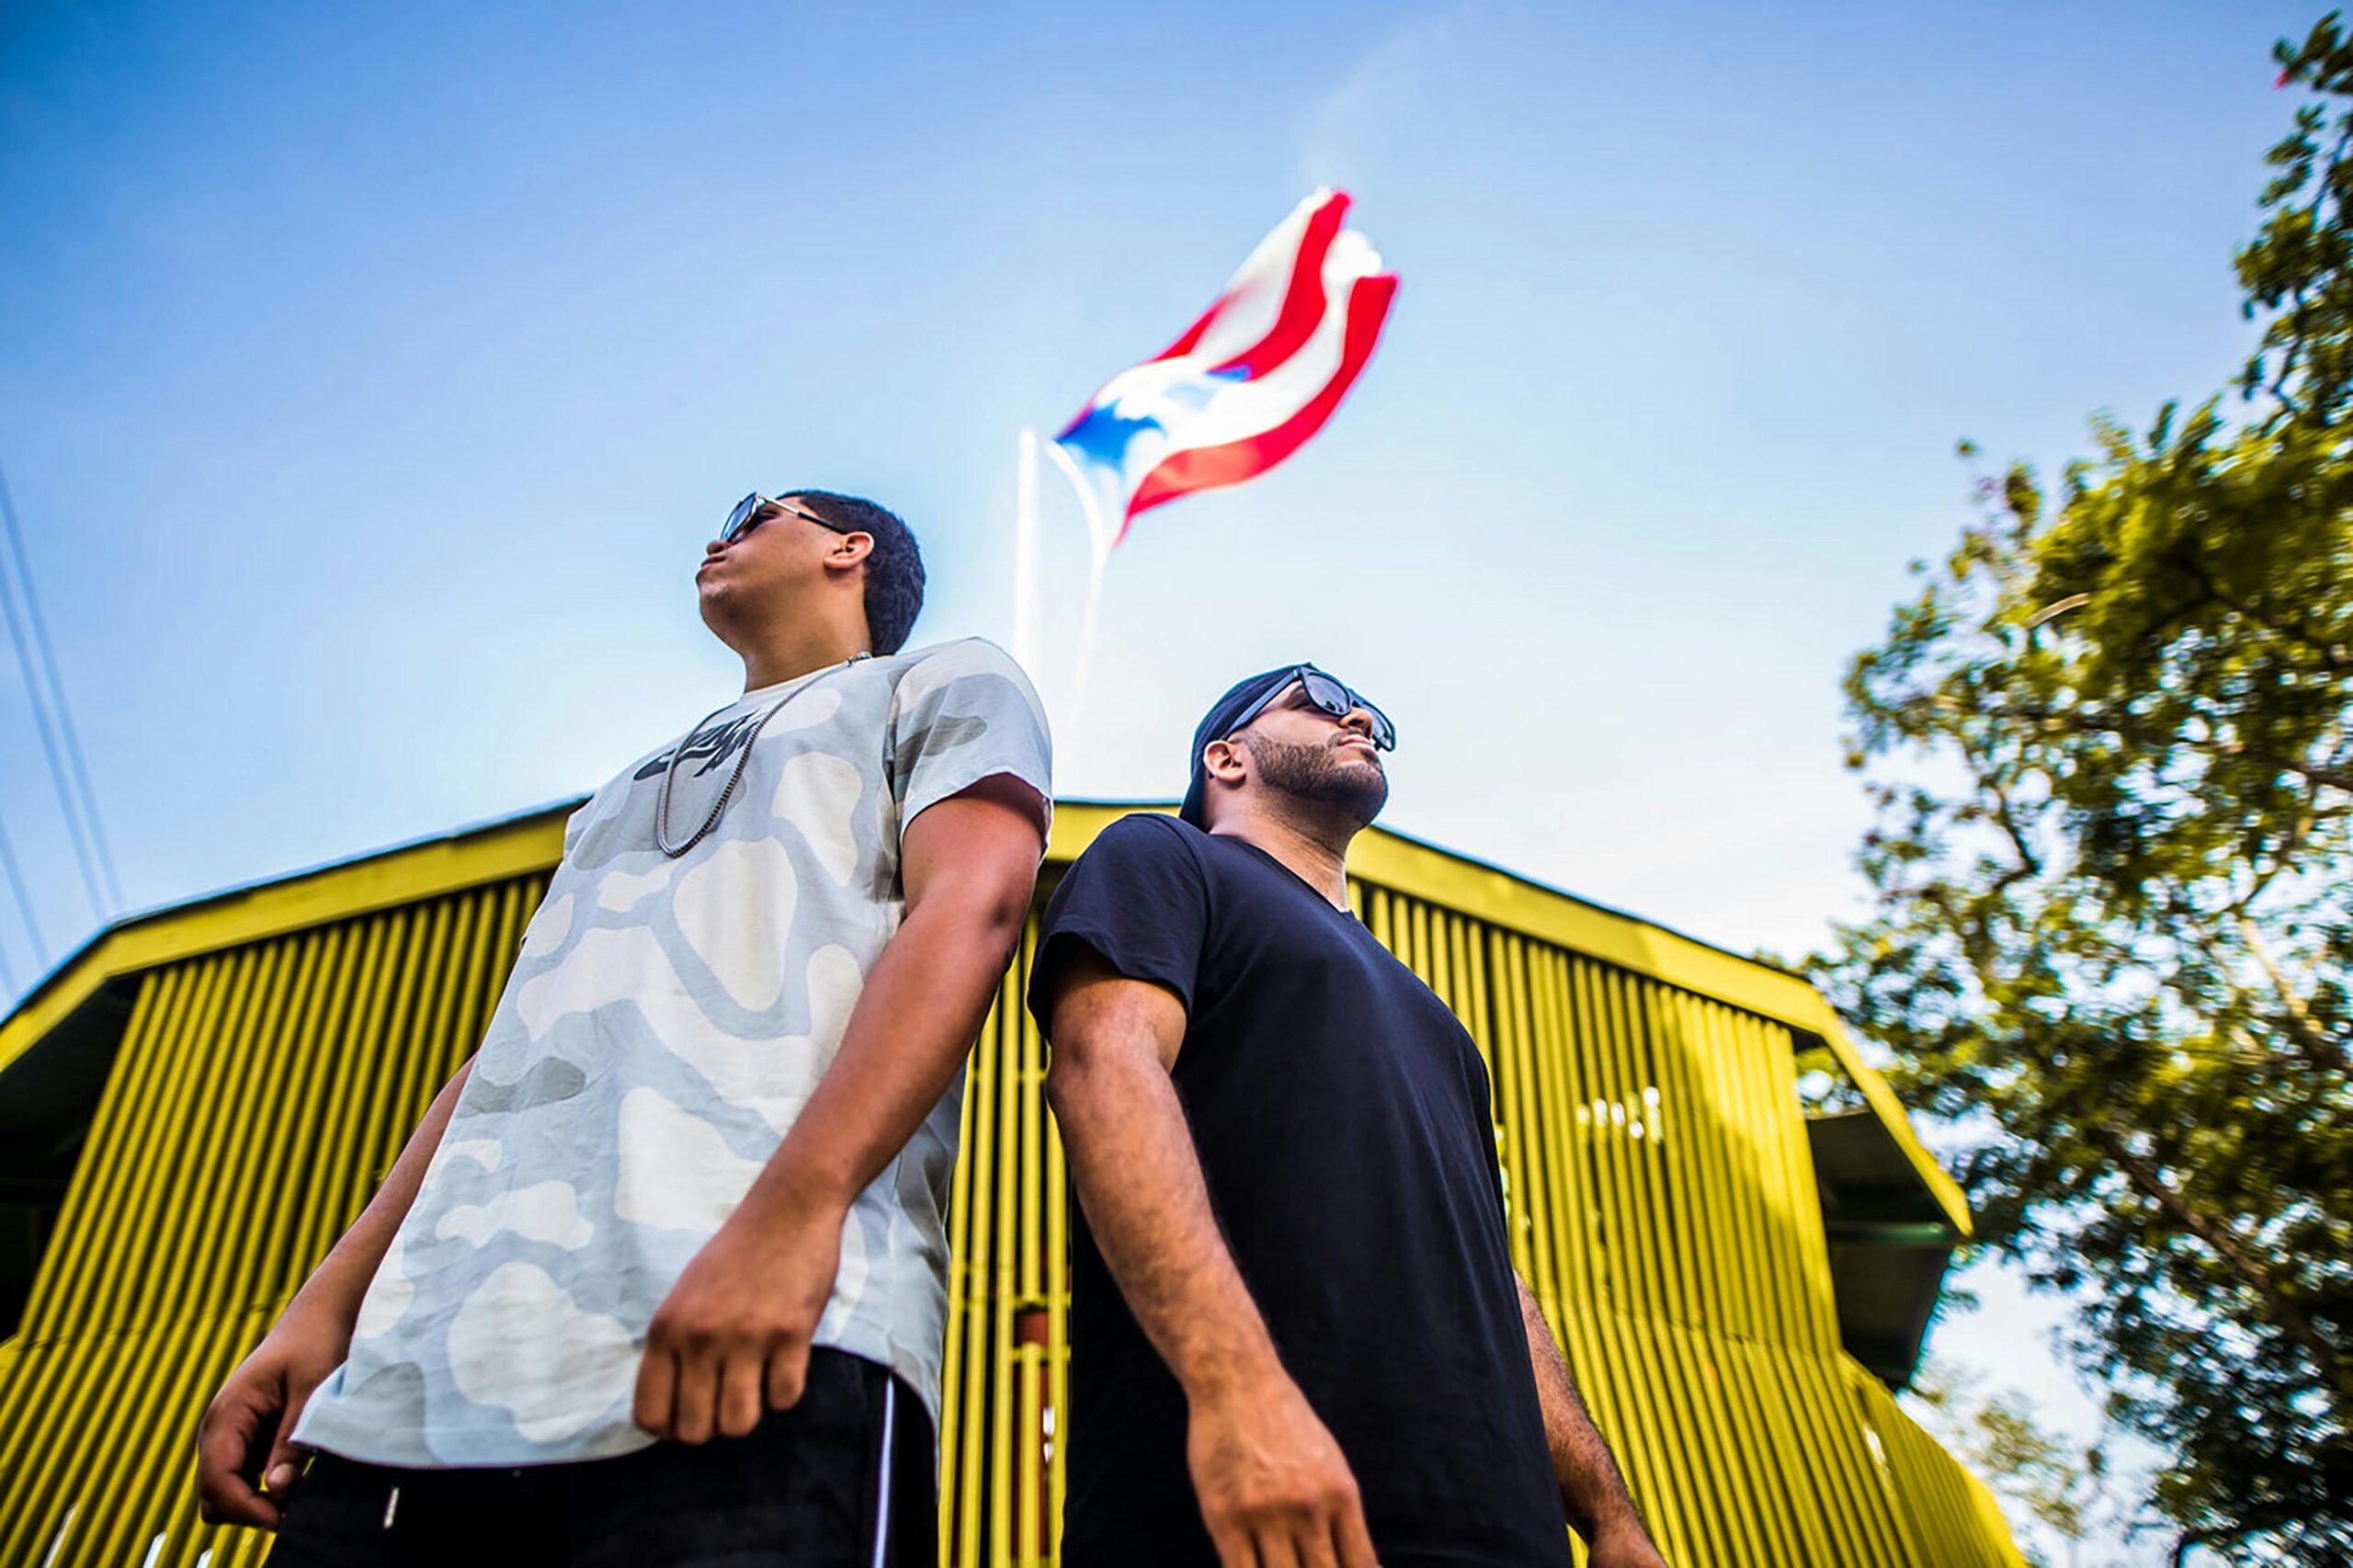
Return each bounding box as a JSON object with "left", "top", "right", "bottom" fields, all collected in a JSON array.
[{"left": 1186, "top": 1378, "right": 1374, "bottom": 1568}]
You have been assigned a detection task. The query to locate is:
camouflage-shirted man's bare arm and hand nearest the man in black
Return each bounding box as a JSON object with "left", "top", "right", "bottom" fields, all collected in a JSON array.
[{"left": 633, "top": 775, "right": 1042, "bottom": 1443}]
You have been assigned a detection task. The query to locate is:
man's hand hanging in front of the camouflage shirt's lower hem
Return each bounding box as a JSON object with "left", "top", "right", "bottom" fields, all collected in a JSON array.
[{"left": 633, "top": 1200, "right": 847, "bottom": 1443}]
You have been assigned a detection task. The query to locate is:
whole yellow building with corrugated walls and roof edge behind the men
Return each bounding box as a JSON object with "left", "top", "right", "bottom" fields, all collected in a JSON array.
[{"left": 0, "top": 802, "right": 2021, "bottom": 1568}]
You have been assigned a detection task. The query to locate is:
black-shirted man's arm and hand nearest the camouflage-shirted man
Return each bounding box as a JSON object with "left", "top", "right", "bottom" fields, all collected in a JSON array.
[{"left": 1045, "top": 951, "right": 1374, "bottom": 1568}]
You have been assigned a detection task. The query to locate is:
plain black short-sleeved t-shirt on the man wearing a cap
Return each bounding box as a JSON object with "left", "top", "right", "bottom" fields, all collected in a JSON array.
[{"left": 1029, "top": 814, "right": 1572, "bottom": 1568}]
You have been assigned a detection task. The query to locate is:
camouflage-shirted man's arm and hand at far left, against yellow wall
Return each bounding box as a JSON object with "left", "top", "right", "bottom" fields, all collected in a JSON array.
[{"left": 195, "top": 1057, "right": 473, "bottom": 1530}]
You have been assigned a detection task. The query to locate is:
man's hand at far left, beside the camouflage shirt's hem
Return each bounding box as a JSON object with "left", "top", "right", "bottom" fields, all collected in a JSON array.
[{"left": 195, "top": 1313, "right": 350, "bottom": 1530}]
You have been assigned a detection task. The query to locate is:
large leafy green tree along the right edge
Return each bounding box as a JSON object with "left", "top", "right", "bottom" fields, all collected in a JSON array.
[{"left": 1810, "top": 14, "right": 2353, "bottom": 1563}]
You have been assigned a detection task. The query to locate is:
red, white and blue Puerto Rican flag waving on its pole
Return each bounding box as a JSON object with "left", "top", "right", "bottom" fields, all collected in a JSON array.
[{"left": 1054, "top": 190, "right": 1398, "bottom": 541}]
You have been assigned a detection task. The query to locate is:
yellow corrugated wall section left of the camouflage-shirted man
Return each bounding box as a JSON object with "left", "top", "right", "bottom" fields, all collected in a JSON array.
[{"left": 0, "top": 876, "right": 546, "bottom": 1568}]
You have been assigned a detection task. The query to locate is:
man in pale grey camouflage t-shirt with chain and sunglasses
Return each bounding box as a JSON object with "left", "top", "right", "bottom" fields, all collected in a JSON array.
[{"left": 200, "top": 492, "right": 1051, "bottom": 1568}]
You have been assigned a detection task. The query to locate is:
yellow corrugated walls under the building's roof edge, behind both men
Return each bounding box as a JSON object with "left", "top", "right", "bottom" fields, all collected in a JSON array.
[{"left": 0, "top": 857, "right": 2021, "bottom": 1568}]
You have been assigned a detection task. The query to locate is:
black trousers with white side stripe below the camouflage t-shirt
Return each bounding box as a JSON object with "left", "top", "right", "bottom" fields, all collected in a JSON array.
[{"left": 268, "top": 1349, "right": 938, "bottom": 1568}]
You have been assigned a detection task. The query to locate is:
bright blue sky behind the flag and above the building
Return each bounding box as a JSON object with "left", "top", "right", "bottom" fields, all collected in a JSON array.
[{"left": 0, "top": 3, "right": 2315, "bottom": 1553}]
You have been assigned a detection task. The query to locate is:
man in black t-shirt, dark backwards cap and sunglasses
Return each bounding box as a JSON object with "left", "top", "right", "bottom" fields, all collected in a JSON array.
[{"left": 1029, "top": 664, "right": 1664, "bottom": 1568}]
